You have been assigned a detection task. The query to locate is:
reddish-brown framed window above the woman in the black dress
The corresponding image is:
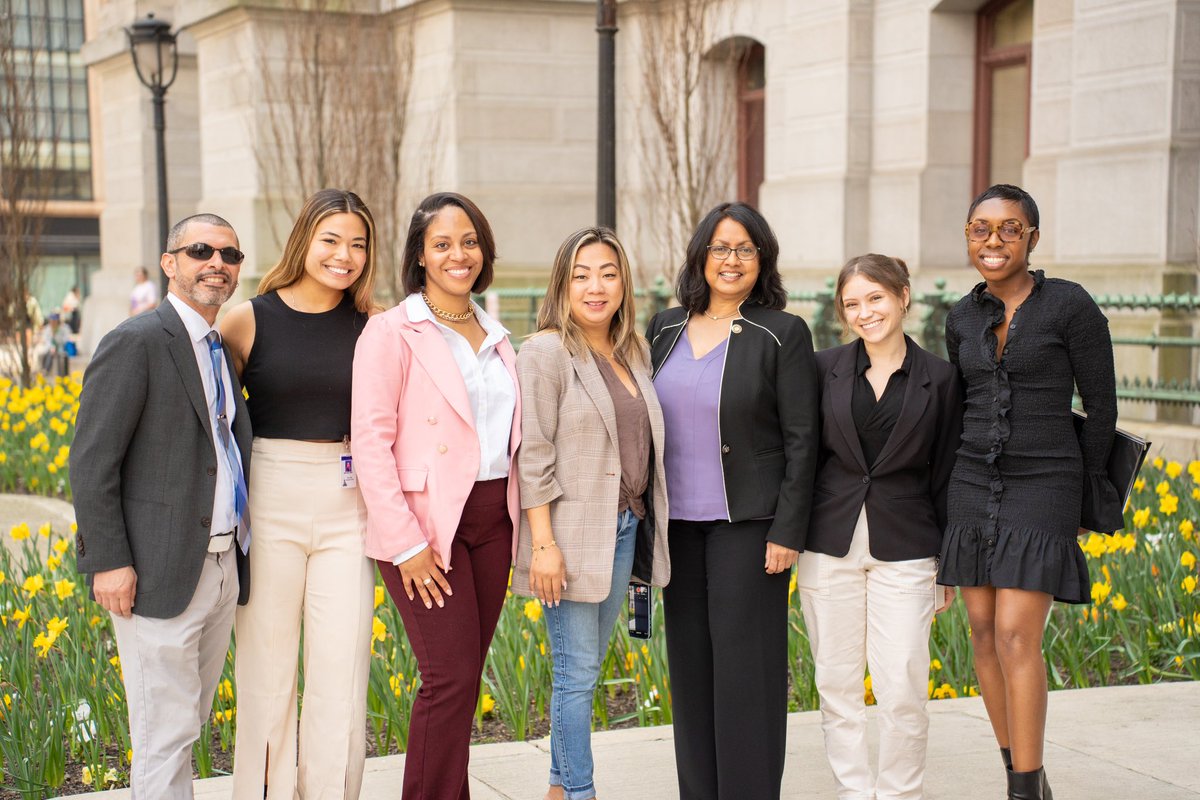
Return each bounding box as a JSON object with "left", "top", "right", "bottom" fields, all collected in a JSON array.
[{"left": 972, "top": 0, "right": 1033, "bottom": 193}]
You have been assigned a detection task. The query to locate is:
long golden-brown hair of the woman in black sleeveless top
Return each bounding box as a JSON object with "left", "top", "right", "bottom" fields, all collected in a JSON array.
[{"left": 258, "top": 188, "right": 376, "bottom": 313}]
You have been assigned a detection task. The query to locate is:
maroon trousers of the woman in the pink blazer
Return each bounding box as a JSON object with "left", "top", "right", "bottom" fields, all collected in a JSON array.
[{"left": 376, "top": 479, "right": 512, "bottom": 800}]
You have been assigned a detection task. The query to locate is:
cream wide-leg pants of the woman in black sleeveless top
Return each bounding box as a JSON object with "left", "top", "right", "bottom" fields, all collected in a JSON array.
[{"left": 233, "top": 438, "right": 374, "bottom": 800}]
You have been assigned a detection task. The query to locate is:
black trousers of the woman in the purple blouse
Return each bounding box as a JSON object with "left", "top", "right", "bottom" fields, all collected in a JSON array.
[{"left": 662, "top": 519, "right": 790, "bottom": 800}]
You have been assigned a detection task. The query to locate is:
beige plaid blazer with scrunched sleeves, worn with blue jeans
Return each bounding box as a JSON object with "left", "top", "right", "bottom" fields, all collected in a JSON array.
[{"left": 512, "top": 333, "right": 671, "bottom": 602}]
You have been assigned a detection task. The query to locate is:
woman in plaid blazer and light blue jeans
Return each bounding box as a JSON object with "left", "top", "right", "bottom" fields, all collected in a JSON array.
[{"left": 512, "top": 228, "right": 670, "bottom": 800}]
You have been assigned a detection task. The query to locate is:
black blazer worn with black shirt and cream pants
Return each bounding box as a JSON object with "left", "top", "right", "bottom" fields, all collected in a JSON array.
[{"left": 808, "top": 337, "right": 962, "bottom": 561}]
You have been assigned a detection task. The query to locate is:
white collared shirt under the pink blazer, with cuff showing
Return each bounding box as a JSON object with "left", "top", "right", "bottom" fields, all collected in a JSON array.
[{"left": 391, "top": 293, "right": 517, "bottom": 564}]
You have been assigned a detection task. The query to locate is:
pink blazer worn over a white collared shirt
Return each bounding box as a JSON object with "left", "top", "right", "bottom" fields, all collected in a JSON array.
[{"left": 350, "top": 302, "right": 521, "bottom": 569}]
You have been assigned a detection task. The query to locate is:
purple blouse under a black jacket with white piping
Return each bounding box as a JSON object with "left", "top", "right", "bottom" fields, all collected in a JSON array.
[{"left": 654, "top": 329, "right": 730, "bottom": 522}]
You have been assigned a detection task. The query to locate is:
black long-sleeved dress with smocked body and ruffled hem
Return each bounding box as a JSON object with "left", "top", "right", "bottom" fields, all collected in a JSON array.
[{"left": 937, "top": 270, "right": 1121, "bottom": 603}]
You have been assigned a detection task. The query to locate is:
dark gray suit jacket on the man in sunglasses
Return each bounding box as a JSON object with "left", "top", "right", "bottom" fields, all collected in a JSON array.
[{"left": 71, "top": 302, "right": 251, "bottom": 618}]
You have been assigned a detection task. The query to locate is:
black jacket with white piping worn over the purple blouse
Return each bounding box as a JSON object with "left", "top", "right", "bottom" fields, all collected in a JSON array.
[{"left": 646, "top": 303, "right": 820, "bottom": 551}]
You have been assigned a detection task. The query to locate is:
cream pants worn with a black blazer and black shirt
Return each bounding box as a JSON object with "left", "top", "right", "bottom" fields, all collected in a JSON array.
[{"left": 796, "top": 507, "right": 937, "bottom": 800}]
